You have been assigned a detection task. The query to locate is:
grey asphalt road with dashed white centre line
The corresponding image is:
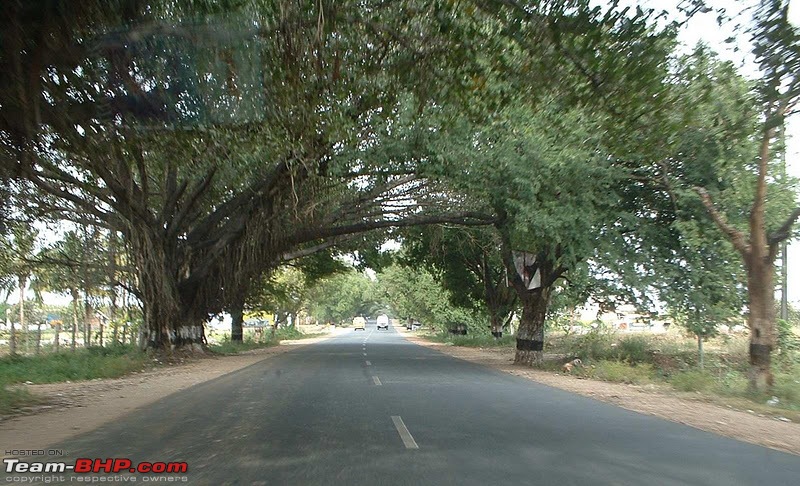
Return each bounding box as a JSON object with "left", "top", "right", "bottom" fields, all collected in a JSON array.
[{"left": 17, "top": 322, "right": 800, "bottom": 486}]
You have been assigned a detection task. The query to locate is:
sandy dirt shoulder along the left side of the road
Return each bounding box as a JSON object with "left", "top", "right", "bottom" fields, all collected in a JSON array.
[{"left": 0, "top": 336, "right": 328, "bottom": 457}]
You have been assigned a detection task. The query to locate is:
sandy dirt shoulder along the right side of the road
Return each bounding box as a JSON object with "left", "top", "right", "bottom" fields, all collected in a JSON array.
[{"left": 401, "top": 330, "right": 800, "bottom": 455}]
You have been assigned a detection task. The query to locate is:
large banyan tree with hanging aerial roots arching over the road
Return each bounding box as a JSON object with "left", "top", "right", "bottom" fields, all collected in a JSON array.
[{"left": 0, "top": 0, "right": 490, "bottom": 350}]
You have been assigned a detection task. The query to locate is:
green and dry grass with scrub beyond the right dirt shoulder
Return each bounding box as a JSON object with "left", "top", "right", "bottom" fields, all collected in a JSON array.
[{"left": 429, "top": 331, "right": 800, "bottom": 414}]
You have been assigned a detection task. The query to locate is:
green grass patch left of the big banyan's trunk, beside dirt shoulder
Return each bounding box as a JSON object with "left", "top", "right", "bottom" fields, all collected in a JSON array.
[{"left": 0, "top": 345, "right": 148, "bottom": 384}]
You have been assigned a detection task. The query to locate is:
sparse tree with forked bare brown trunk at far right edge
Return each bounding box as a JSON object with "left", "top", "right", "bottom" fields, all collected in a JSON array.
[{"left": 695, "top": 0, "right": 800, "bottom": 392}]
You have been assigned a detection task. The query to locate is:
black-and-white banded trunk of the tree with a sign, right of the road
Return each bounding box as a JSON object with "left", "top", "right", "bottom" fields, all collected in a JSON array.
[{"left": 514, "top": 287, "right": 550, "bottom": 366}]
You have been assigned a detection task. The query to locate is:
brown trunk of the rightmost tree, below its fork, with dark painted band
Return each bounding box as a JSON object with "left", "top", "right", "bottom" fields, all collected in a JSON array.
[{"left": 747, "top": 256, "right": 775, "bottom": 393}]
